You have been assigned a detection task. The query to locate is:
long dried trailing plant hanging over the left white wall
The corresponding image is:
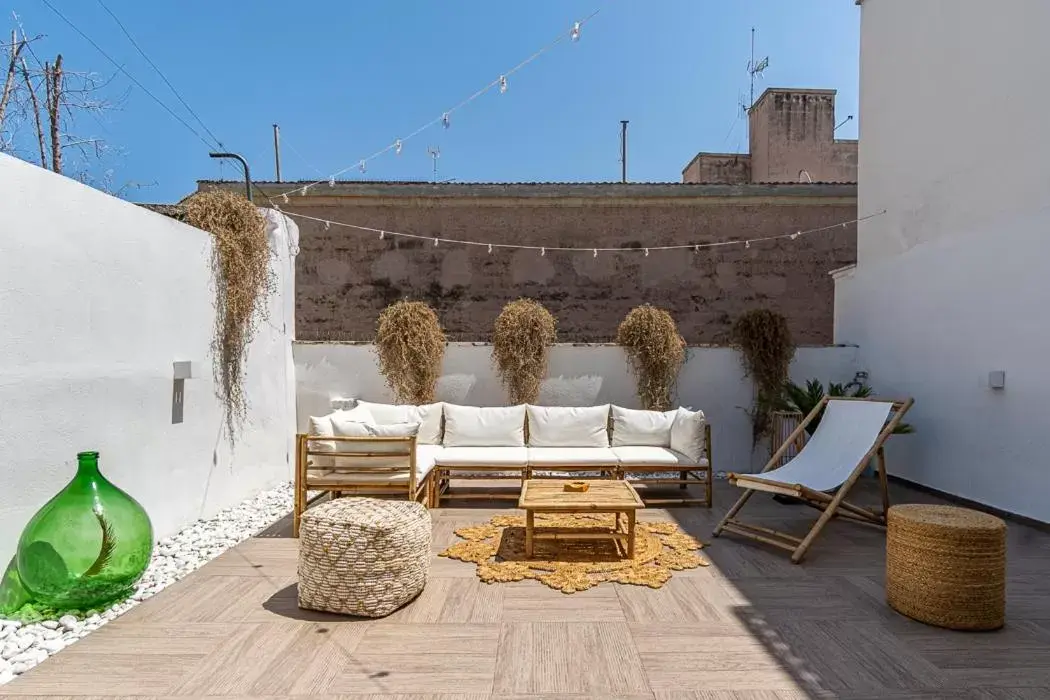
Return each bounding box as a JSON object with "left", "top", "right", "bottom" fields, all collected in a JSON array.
[{"left": 185, "top": 190, "right": 276, "bottom": 443}]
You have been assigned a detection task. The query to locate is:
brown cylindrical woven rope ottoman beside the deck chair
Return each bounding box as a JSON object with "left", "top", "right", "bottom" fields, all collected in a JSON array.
[{"left": 886, "top": 504, "right": 1006, "bottom": 630}]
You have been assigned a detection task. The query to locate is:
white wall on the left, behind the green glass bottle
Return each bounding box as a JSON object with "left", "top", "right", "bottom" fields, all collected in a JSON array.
[{"left": 0, "top": 155, "right": 298, "bottom": 566}]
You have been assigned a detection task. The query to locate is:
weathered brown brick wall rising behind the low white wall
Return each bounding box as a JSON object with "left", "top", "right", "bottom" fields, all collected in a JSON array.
[{"left": 256, "top": 186, "right": 856, "bottom": 343}]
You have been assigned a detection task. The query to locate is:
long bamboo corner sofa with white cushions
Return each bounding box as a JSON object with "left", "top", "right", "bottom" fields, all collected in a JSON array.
[{"left": 295, "top": 401, "right": 712, "bottom": 532}]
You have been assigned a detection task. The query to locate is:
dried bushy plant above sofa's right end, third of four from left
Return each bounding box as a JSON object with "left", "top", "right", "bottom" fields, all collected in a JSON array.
[{"left": 616, "top": 304, "right": 686, "bottom": 410}]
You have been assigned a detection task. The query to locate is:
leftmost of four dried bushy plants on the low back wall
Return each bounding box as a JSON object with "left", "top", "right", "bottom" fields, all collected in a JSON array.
[{"left": 376, "top": 301, "right": 445, "bottom": 404}]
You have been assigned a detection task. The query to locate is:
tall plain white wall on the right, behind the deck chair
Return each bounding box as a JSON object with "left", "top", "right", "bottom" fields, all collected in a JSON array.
[{"left": 835, "top": 0, "right": 1050, "bottom": 522}]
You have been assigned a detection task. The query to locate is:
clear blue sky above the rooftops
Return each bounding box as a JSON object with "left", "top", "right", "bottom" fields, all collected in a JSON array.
[{"left": 13, "top": 0, "right": 860, "bottom": 201}]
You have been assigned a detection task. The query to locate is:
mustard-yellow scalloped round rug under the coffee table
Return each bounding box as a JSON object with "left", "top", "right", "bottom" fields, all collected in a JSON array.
[{"left": 439, "top": 514, "right": 709, "bottom": 593}]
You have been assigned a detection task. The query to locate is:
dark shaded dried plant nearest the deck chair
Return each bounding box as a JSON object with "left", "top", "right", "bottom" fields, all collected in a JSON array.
[{"left": 733, "top": 309, "right": 795, "bottom": 447}]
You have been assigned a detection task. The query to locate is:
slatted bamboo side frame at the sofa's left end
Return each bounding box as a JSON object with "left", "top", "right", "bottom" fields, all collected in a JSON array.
[{"left": 292, "top": 433, "right": 433, "bottom": 537}]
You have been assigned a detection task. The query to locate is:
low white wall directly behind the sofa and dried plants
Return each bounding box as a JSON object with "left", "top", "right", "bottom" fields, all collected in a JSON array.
[{"left": 294, "top": 342, "right": 857, "bottom": 471}]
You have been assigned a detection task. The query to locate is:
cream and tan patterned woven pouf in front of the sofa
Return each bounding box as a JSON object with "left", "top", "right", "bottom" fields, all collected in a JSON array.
[{"left": 299, "top": 497, "right": 431, "bottom": 617}]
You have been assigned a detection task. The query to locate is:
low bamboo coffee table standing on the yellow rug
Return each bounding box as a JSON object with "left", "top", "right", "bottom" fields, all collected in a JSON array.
[{"left": 518, "top": 479, "right": 646, "bottom": 559}]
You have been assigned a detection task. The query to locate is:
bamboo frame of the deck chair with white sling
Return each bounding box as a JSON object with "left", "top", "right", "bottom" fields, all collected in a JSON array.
[{"left": 714, "top": 396, "right": 915, "bottom": 564}]
